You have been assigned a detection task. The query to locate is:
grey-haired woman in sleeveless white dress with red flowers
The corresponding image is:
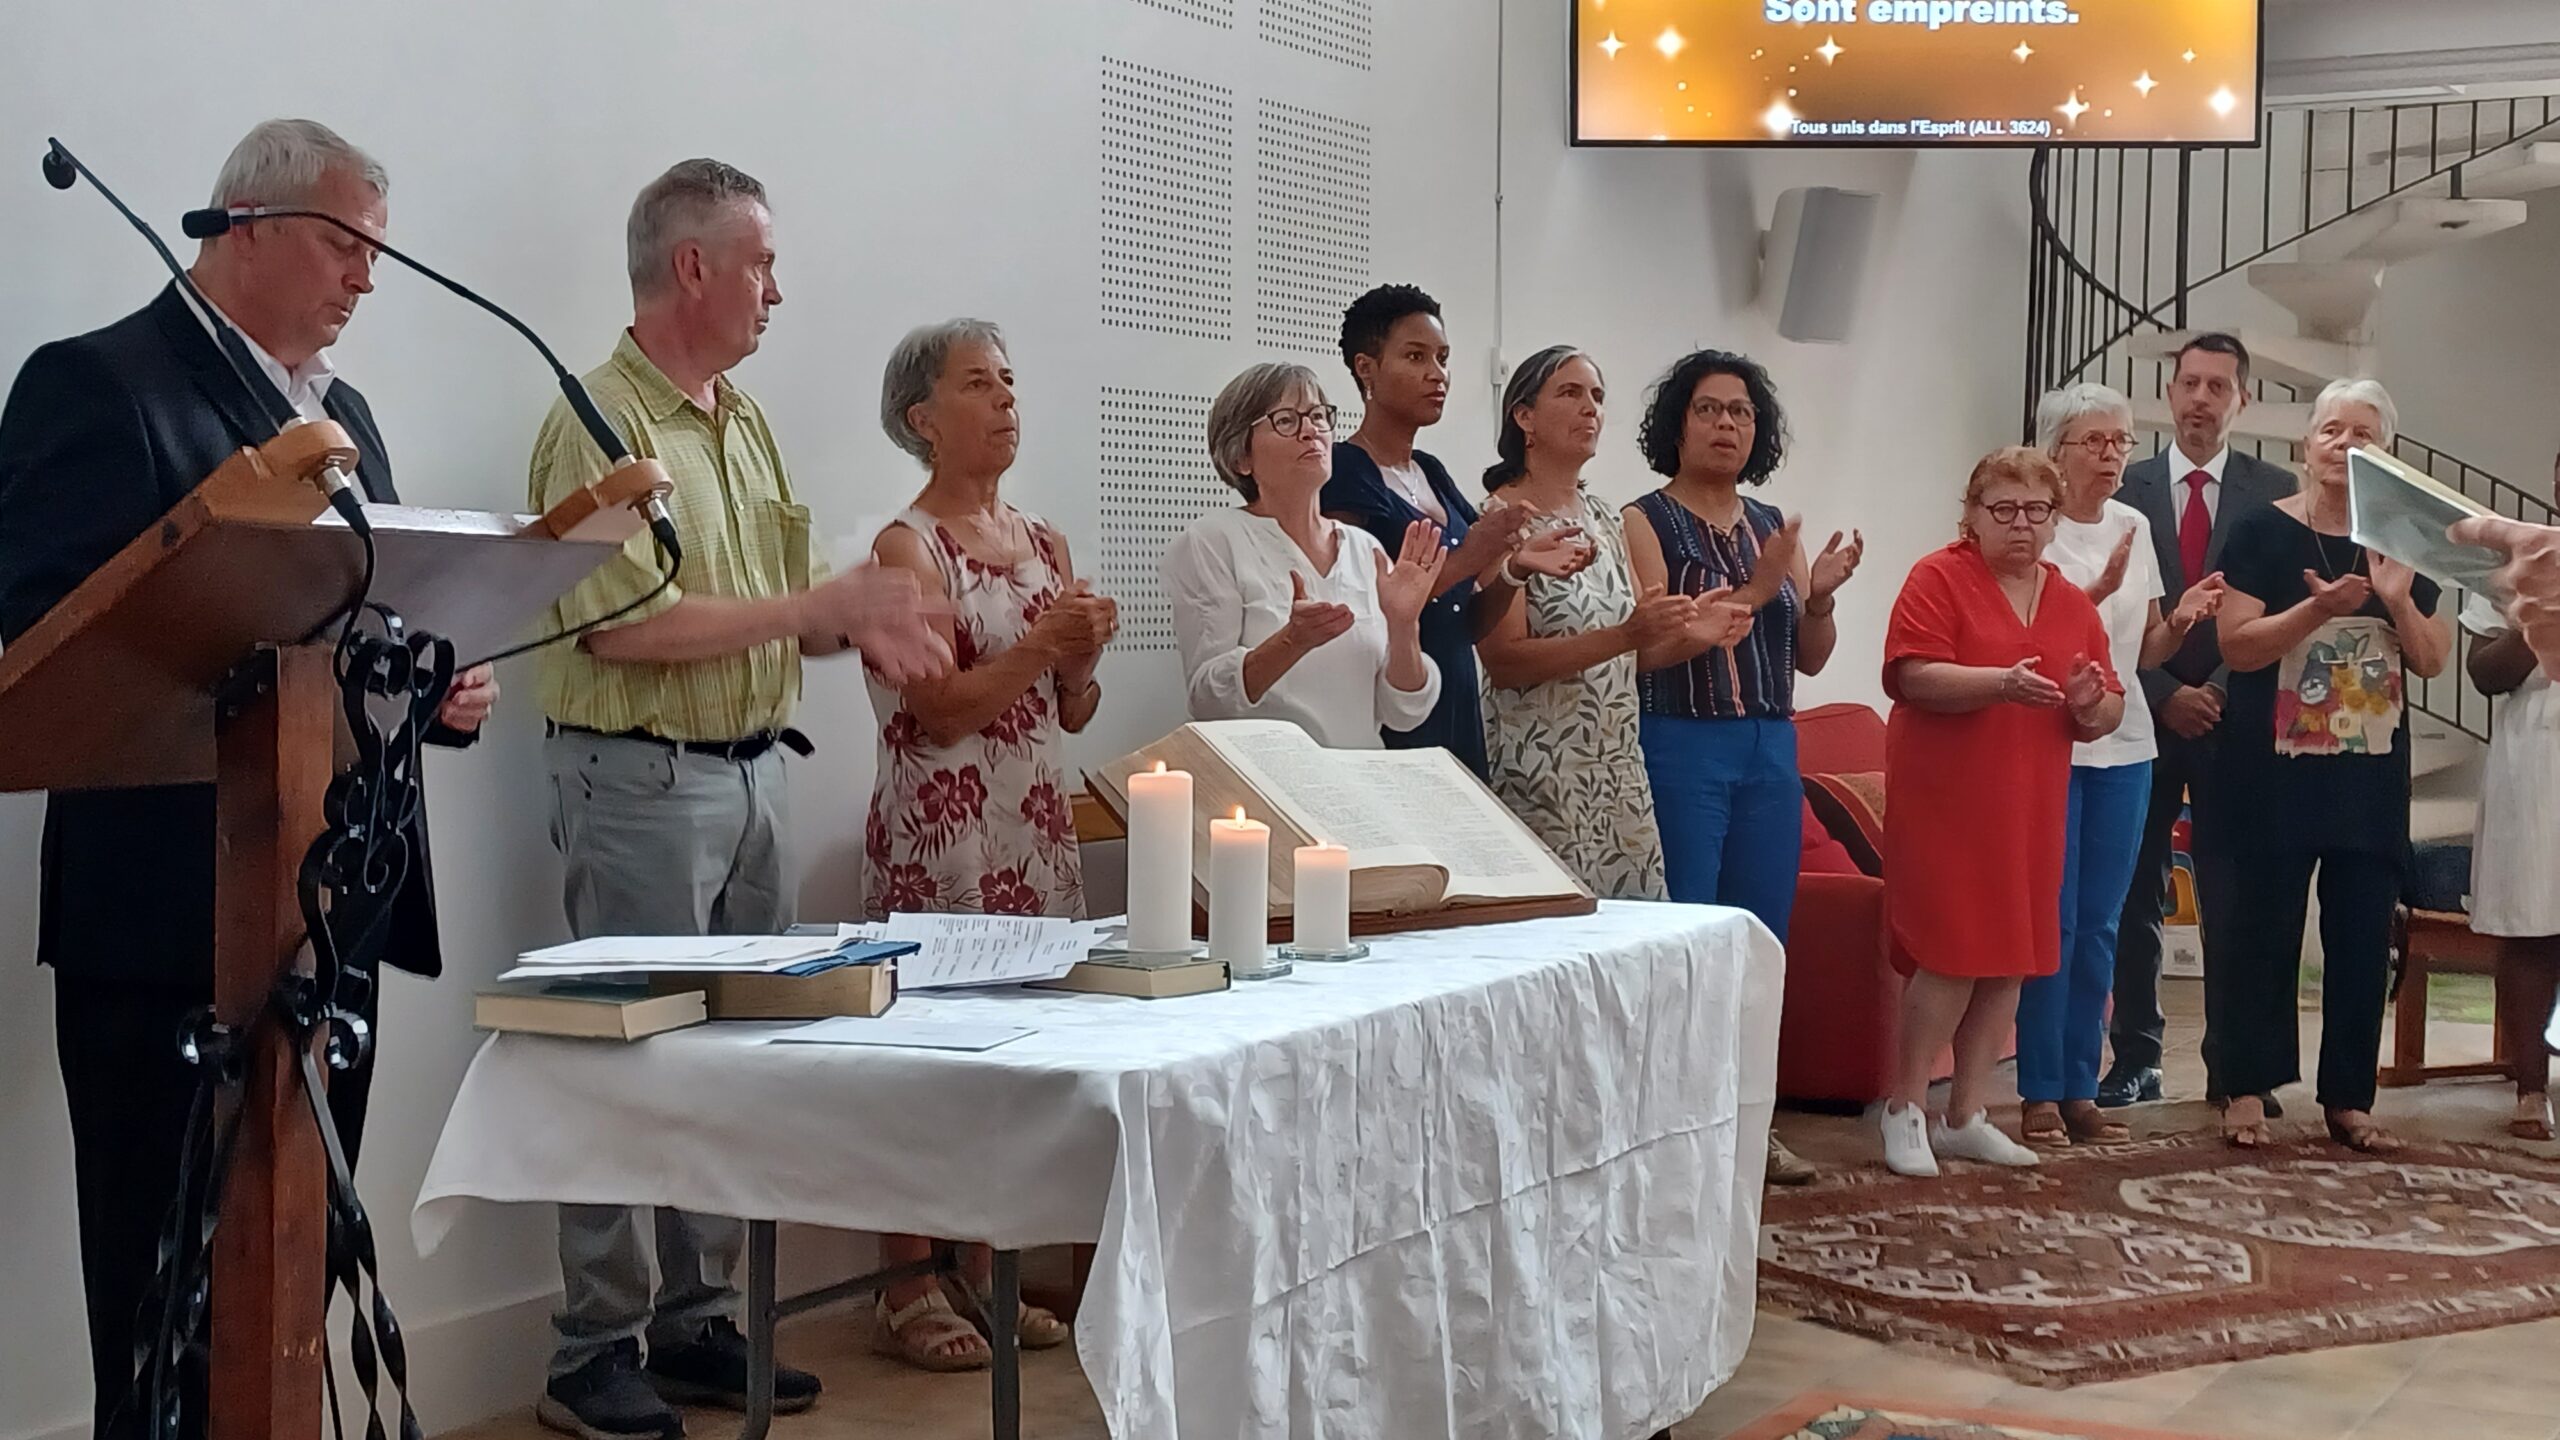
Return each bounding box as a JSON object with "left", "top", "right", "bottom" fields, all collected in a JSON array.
[{"left": 865, "top": 320, "right": 1119, "bottom": 1371}]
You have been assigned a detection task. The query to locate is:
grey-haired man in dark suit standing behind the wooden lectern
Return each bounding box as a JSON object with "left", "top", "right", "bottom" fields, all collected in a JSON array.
[{"left": 0, "top": 120, "right": 497, "bottom": 1435}]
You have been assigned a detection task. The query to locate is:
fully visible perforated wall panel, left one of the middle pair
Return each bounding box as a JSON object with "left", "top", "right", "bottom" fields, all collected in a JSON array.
[{"left": 1103, "top": 59, "right": 1236, "bottom": 341}]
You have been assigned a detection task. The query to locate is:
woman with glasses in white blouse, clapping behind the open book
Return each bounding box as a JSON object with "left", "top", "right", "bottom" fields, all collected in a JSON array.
[{"left": 1165, "top": 364, "right": 1444, "bottom": 751}]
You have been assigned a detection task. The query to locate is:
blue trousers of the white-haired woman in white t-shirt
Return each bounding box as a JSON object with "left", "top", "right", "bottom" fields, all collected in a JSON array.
[{"left": 2017, "top": 761, "right": 2150, "bottom": 1102}]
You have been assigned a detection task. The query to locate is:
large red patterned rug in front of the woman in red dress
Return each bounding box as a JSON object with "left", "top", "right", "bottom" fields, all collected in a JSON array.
[{"left": 1761, "top": 1135, "right": 2560, "bottom": 1383}]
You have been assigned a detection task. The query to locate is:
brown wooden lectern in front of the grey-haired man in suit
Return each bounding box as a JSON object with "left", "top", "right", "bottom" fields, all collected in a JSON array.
[{"left": 0, "top": 423, "right": 663, "bottom": 1440}]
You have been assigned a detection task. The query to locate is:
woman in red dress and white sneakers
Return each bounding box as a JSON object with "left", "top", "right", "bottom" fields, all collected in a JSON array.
[{"left": 1882, "top": 448, "right": 2125, "bottom": 1176}]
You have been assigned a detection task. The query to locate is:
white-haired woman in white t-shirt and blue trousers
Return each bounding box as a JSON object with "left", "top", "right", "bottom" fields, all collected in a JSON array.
[{"left": 2017, "top": 384, "right": 2222, "bottom": 1145}]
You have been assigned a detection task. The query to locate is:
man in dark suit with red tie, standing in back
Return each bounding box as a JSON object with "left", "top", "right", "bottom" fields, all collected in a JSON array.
[{"left": 2097, "top": 333, "right": 2294, "bottom": 1107}]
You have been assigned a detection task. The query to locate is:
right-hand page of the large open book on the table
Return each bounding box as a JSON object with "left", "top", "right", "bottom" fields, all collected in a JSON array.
[{"left": 1326, "top": 751, "right": 1582, "bottom": 902}]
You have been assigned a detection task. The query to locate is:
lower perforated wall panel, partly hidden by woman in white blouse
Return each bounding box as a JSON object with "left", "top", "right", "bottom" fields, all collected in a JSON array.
[{"left": 1096, "top": 384, "right": 1236, "bottom": 651}]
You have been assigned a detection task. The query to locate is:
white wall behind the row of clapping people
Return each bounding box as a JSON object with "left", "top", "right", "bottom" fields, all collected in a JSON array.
[{"left": 0, "top": 0, "right": 2025, "bottom": 1440}]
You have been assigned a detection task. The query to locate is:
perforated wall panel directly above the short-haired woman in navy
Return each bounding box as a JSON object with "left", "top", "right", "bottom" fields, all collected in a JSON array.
[{"left": 1254, "top": 100, "right": 1372, "bottom": 354}]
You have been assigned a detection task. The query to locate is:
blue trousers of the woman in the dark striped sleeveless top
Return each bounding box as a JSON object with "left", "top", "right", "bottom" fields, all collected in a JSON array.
[{"left": 1638, "top": 715, "right": 1805, "bottom": 943}]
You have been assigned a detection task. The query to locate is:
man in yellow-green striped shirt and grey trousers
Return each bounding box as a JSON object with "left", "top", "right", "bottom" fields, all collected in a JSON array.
[{"left": 527, "top": 159, "right": 950, "bottom": 1440}]
